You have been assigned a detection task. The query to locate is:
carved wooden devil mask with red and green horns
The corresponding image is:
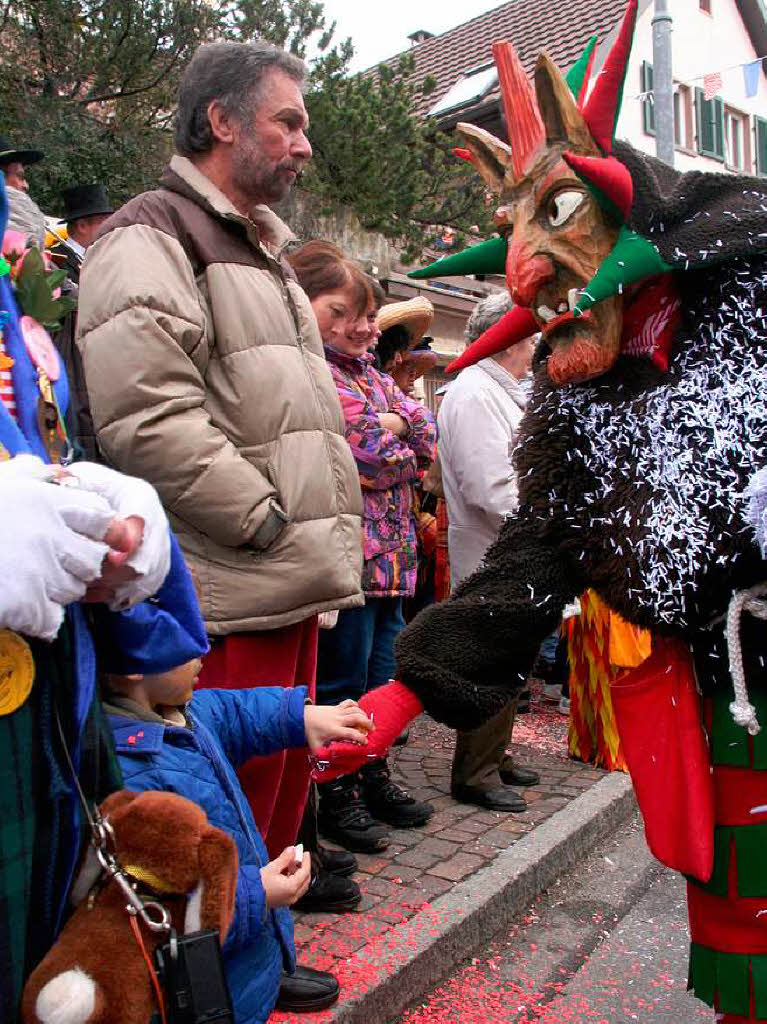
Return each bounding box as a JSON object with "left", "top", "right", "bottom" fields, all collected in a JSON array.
[{"left": 411, "top": 0, "right": 667, "bottom": 384}]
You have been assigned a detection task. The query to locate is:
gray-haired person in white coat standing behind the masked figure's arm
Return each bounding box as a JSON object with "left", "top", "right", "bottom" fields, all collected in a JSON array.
[{"left": 437, "top": 293, "right": 539, "bottom": 812}]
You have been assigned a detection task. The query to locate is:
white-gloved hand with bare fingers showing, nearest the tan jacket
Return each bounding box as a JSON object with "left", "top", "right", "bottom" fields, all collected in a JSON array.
[{"left": 67, "top": 462, "right": 170, "bottom": 611}]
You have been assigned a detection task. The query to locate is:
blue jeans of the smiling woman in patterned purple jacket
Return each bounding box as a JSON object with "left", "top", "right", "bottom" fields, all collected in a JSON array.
[{"left": 316, "top": 597, "right": 404, "bottom": 705}]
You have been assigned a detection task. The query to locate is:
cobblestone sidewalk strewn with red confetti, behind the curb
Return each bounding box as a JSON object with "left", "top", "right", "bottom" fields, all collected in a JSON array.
[{"left": 270, "top": 686, "right": 604, "bottom": 1024}]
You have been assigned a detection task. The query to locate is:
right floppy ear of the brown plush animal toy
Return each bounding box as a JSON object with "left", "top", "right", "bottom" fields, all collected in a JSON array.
[{"left": 183, "top": 825, "right": 239, "bottom": 944}]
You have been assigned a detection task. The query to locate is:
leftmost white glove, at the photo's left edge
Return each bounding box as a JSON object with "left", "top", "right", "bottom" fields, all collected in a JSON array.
[{"left": 0, "top": 473, "right": 115, "bottom": 640}]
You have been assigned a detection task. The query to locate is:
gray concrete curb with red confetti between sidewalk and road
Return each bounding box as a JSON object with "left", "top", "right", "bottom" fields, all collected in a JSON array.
[{"left": 324, "top": 772, "right": 636, "bottom": 1024}]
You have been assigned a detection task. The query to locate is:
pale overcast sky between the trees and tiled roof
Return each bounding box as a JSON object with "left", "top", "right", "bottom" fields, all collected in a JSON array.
[{"left": 324, "top": 0, "right": 502, "bottom": 71}]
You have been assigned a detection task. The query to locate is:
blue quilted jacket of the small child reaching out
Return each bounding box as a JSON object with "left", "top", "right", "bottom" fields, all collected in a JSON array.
[{"left": 109, "top": 686, "right": 307, "bottom": 1024}]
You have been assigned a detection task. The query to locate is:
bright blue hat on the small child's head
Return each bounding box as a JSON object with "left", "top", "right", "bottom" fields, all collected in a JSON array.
[{"left": 100, "top": 532, "right": 210, "bottom": 676}]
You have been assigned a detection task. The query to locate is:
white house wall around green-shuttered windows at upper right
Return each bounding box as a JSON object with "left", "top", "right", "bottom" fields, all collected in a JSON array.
[{"left": 614, "top": 0, "right": 767, "bottom": 174}]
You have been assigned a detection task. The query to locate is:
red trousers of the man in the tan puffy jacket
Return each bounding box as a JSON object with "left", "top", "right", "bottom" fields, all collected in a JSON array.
[{"left": 200, "top": 615, "right": 317, "bottom": 859}]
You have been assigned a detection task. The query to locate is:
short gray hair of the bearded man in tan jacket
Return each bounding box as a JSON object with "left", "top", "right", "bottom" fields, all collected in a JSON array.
[{"left": 174, "top": 41, "right": 306, "bottom": 157}]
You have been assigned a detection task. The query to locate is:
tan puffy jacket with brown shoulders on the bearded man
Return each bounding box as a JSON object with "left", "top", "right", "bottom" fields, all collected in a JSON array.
[{"left": 78, "top": 157, "right": 363, "bottom": 635}]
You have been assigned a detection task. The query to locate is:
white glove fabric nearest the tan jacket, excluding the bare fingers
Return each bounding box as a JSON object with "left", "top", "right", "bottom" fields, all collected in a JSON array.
[{"left": 67, "top": 462, "right": 170, "bottom": 611}]
